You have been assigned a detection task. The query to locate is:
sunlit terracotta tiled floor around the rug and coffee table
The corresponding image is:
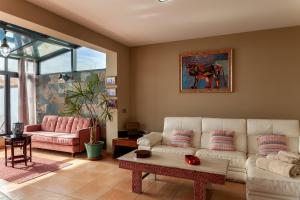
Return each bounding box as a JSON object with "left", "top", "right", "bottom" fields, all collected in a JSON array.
[{"left": 0, "top": 150, "right": 245, "bottom": 200}]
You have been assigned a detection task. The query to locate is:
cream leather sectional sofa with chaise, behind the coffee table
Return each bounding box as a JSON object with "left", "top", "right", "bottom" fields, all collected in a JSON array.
[{"left": 138, "top": 117, "right": 300, "bottom": 200}]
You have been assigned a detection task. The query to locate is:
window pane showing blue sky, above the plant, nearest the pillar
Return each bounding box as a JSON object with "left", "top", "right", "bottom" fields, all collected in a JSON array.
[{"left": 76, "top": 47, "right": 106, "bottom": 71}]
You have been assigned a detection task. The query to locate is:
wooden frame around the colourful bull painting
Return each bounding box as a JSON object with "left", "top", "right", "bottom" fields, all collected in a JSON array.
[{"left": 179, "top": 48, "right": 233, "bottom": 93}]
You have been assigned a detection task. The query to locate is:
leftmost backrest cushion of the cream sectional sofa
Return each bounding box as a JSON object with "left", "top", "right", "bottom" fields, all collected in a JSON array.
[{"left": 162, "top": 117, "right": 201, "bottom": 148}]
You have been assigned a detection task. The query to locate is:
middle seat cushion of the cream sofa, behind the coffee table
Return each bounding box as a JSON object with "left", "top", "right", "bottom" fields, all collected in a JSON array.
[{"left": 196, "top": 149, "right": 247, "bottom": 169}]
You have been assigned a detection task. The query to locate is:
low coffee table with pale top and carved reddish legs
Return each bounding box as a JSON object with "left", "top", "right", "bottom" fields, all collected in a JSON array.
[{"left": 118, "top": 151, "right": 229, "bottom": 200}]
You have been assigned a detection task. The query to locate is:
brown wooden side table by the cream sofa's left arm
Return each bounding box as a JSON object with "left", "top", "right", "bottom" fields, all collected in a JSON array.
[{"left": 112, "top": 138, "right": 138, "bottom": 158}]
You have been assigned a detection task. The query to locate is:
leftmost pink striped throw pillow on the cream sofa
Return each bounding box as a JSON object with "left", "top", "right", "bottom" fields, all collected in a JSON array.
[{"left": 171, "top": 130, "right": 193, "bottom": 148}]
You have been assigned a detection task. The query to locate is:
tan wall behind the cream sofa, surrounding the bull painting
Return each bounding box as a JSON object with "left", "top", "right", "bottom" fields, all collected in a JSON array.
[{"left": 130, "top": 26, "right": 300, "bottom": 131}]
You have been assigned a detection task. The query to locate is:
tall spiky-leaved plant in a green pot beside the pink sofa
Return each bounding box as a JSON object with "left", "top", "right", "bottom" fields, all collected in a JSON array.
[{"left": 63, "top": 74, "right": 112, "bottom": 160}]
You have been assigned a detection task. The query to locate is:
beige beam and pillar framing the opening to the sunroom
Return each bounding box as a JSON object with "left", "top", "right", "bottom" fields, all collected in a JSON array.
[{"left": 0, "top": 0, "right": 130, "bottom": 131}]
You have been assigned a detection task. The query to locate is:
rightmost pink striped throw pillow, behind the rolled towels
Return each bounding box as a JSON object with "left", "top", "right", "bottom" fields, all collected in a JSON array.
[{"left": 257, "top": 134, "right": 288, "bottom": 156}]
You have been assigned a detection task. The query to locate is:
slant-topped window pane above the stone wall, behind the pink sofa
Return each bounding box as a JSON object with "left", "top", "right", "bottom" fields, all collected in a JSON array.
[{"left": 40, "top": 52, "right": 71, "bottom": 74}]
